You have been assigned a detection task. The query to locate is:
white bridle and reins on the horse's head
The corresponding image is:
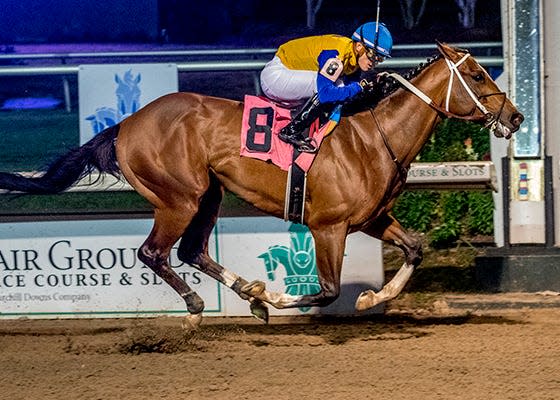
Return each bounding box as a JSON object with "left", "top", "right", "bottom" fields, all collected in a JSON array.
[{"left": 379, "top": 53, "right": 507, "bottom": 131}]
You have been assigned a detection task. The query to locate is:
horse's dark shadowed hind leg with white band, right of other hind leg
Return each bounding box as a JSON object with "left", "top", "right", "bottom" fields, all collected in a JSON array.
[{"left": 178, "top": 175, "right": 268, "bottom": 322}]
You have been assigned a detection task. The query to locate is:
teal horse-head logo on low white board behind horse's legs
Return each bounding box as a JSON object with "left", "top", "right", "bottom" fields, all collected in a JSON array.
[{"left": 259, "top": 224, "right": 321, "bottom": 312}]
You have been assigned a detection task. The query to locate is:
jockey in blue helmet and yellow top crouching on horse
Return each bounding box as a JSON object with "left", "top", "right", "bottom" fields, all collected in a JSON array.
[{"left": 261, "top": 22, "right": 393, "bottom": 153}]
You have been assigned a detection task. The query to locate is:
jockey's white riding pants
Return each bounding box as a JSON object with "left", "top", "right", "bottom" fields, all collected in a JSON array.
[{"left": 261, "top": 56, "right": 317, "bottom": 104}]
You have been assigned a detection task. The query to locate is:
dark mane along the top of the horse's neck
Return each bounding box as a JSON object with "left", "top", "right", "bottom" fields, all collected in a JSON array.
[{"left": 343, "top": 53, "right": 442, "bottom": 115}]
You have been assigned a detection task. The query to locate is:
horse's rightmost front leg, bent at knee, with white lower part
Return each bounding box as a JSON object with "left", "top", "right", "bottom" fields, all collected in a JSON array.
[{"left": 356, "top": 214, "right": 422, "bottom": 311}]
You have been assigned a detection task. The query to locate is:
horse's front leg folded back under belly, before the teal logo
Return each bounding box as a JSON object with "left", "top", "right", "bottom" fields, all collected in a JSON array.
[{"left": 242, "top": 223, "right": 347, "bottom": 308}]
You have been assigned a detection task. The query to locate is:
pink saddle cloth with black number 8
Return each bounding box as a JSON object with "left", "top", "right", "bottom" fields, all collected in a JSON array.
[{"left": 241, "top": 95, "right": 329, "bottom": 172}]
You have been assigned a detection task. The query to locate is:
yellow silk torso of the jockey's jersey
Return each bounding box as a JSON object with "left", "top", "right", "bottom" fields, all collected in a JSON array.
[{"left": 276, "top": 35, "right": 358, "bottom": 75}]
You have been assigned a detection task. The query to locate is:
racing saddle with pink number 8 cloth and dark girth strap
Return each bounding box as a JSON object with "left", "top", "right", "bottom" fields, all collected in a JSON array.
[{"left": 240, "top": 95, "right": 341, "bottom": 224}]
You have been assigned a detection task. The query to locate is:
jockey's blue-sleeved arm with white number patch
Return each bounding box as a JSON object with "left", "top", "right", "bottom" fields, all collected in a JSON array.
[{"left": 317, "top": 50, "right": 362, "bottom": 103}]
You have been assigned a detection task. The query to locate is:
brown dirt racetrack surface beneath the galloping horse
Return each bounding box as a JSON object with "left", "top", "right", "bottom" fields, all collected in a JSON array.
[{"left": 0, "top": 297, "right": 560, "bottom": 400}]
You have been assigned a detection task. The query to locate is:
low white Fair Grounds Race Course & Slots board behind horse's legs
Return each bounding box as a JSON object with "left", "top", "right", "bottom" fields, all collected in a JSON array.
[{"left": 0, "top": 217, "right": 383, "bottom": 318}]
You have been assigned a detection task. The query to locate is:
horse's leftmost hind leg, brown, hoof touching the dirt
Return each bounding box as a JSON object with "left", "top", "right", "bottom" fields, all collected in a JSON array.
[{"left": 138, "top": 209, "right": 204, "bottom": 328}]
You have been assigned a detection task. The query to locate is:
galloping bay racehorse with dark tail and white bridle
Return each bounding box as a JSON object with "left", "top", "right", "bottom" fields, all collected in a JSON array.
[{"left": 0, "top": 43, "right": 523, "bottom": 327}]
